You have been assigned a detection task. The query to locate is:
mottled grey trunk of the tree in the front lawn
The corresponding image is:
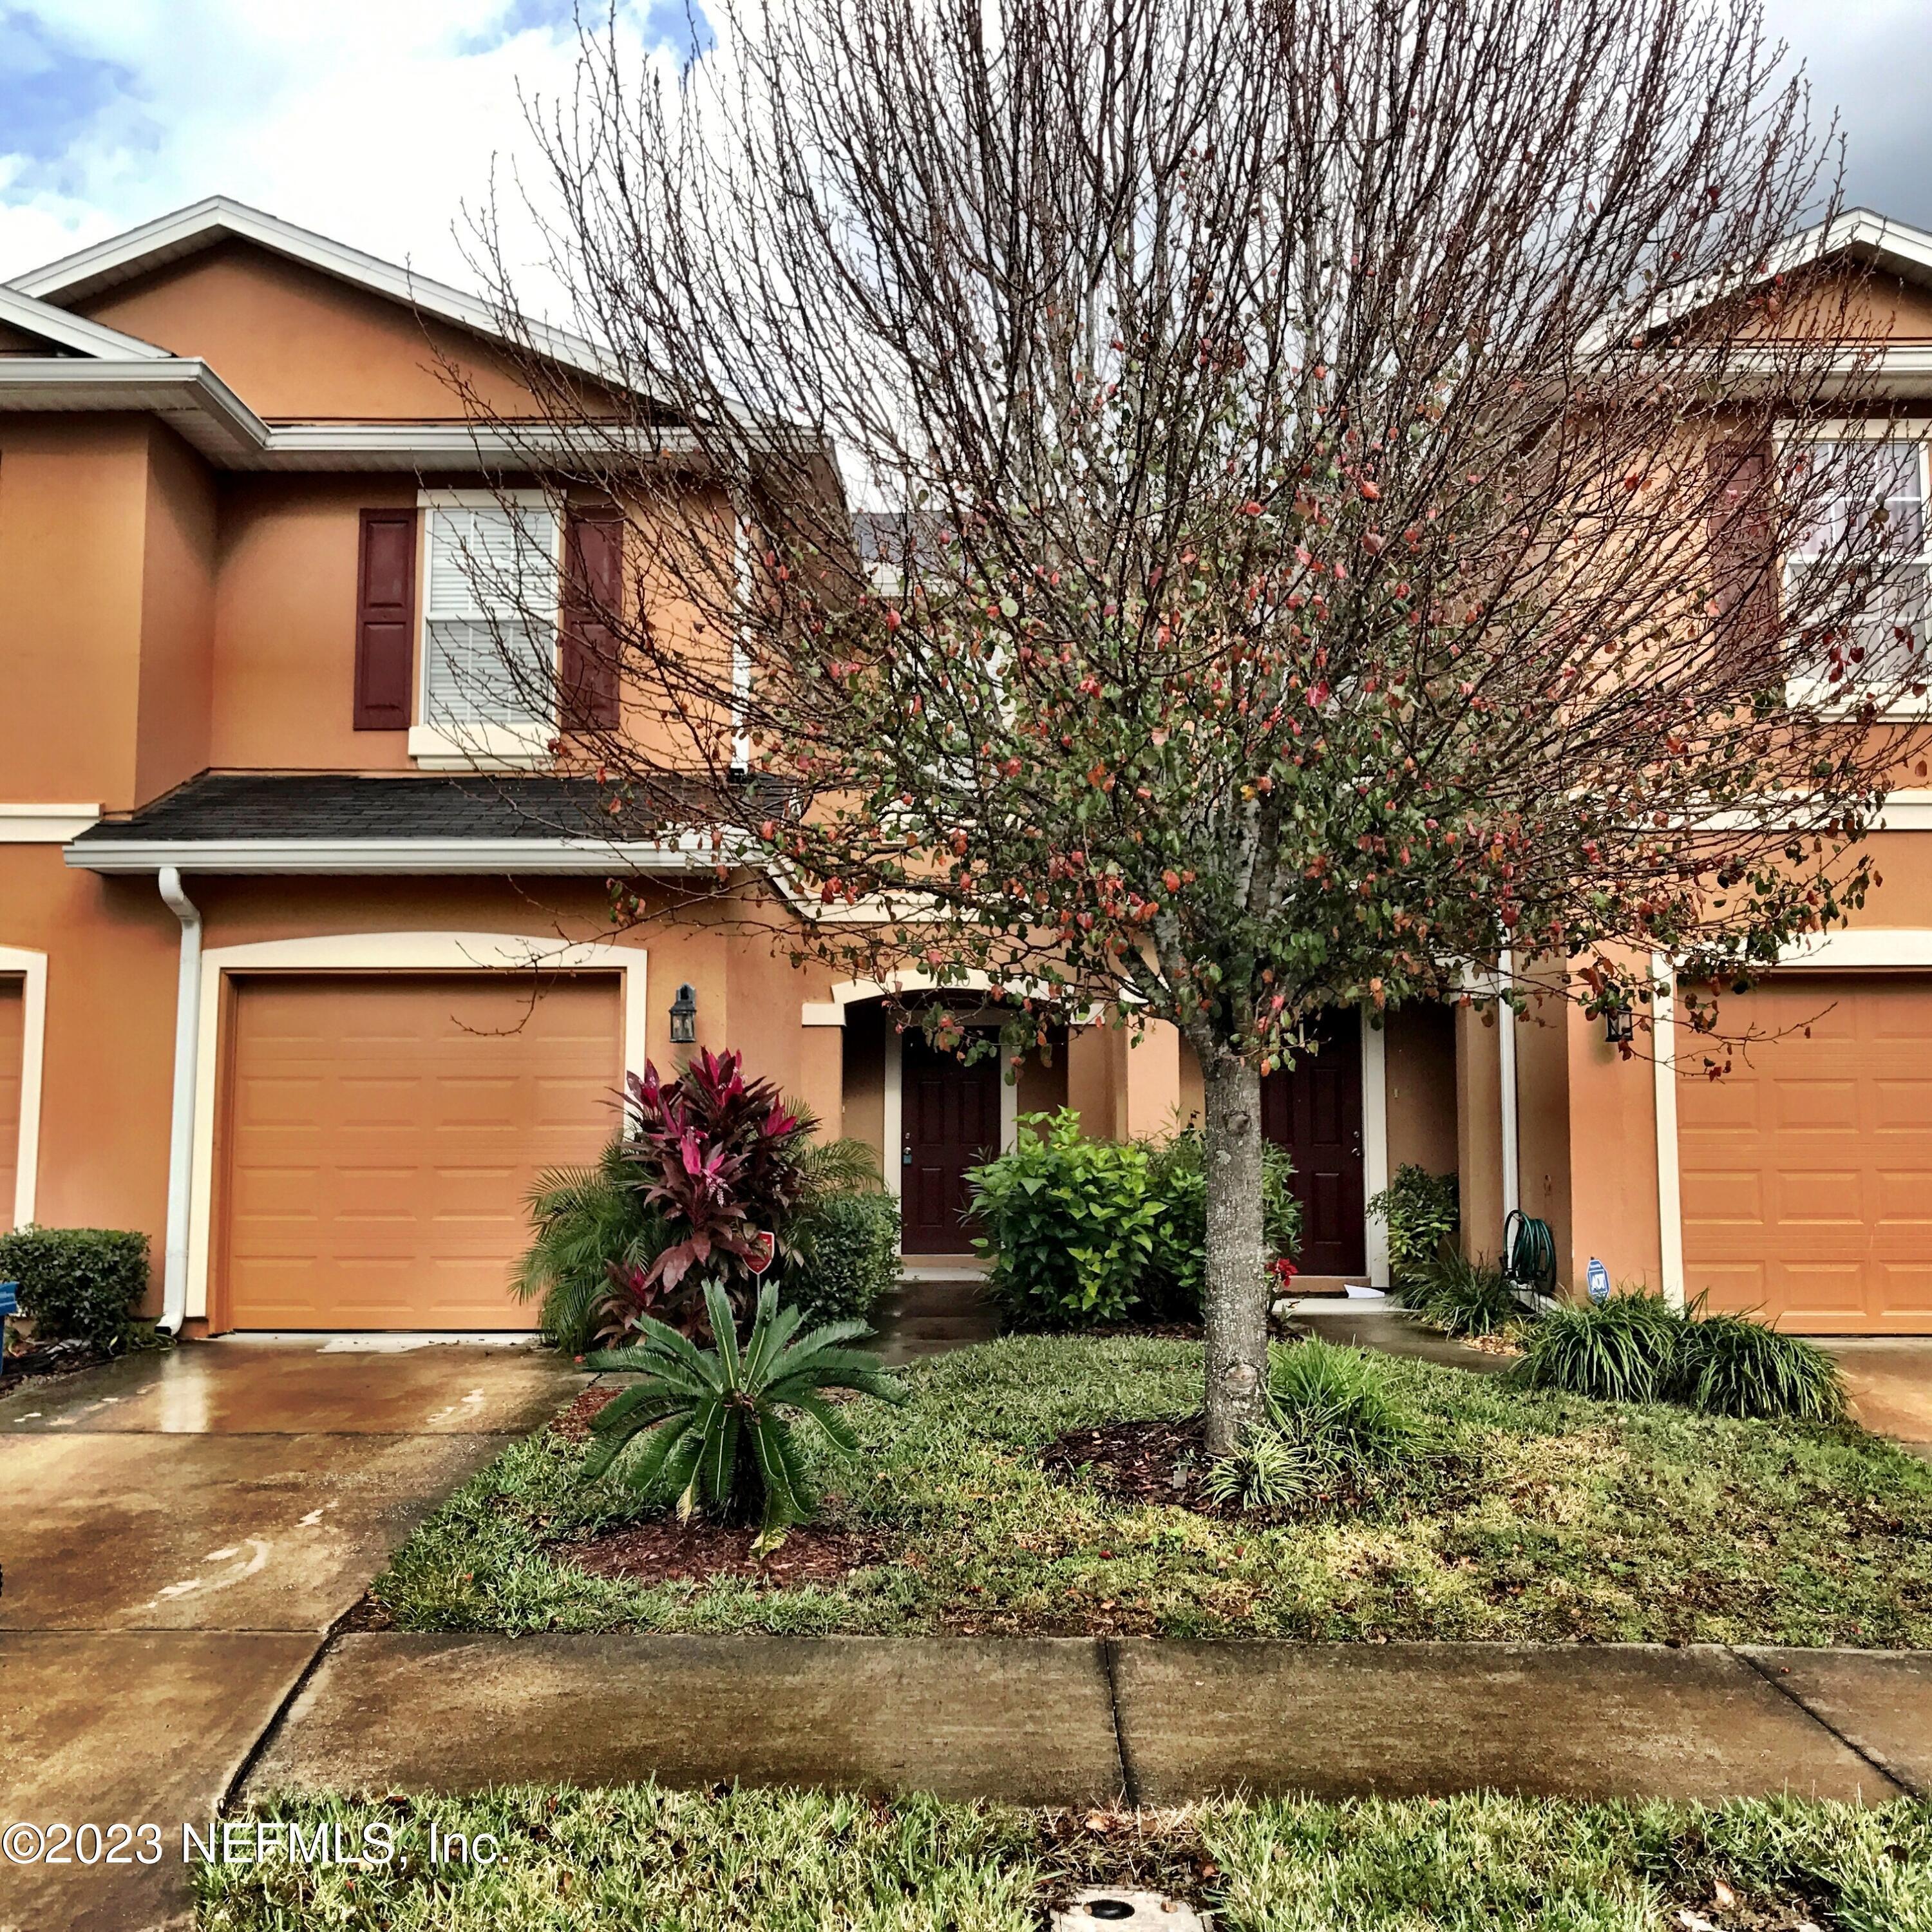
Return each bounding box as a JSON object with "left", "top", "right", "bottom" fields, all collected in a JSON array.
[{"left": 1202, "top": 1055, "right": 1269, "bottom": 1455}]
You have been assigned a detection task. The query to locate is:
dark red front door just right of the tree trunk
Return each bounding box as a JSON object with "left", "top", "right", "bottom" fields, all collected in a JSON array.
[{"left": 1262, "top": 1012, "right": 1368, "bottom": 1275}]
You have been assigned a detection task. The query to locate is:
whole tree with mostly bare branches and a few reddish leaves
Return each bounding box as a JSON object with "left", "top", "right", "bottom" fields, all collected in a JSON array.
[{"left": 460, "top": 0, "right": 1922, "bottom": 1449}]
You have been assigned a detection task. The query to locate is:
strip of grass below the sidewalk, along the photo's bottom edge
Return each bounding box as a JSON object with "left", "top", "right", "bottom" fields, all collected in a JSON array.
[{"left": 199, "top": 1785, "right": 1932, "bottom": 1932}]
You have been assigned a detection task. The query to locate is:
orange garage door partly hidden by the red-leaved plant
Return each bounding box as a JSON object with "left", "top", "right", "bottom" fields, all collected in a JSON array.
[{"left": 222, "top": 974, "right": 622, "bottom": 1329}]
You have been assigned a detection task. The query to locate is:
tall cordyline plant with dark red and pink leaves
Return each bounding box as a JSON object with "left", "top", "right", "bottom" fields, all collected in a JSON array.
[{"left": 618, "top": 1047, "right": 813, "bottom": 1314}]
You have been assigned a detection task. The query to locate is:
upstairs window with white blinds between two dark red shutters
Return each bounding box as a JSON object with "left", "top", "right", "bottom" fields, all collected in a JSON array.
[{"left": 410, "top": 491, "right": 562, "bottom": 767}]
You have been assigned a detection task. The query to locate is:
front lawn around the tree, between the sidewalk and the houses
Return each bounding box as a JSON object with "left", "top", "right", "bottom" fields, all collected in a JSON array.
[{"left": 377, "top": 1337, "right": 1932, "bottom": 1648}]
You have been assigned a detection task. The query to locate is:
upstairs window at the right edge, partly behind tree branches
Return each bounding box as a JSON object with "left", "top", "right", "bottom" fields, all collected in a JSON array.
[{"left": 1785, "top": 439, "right": 1932, "bottom": 709}]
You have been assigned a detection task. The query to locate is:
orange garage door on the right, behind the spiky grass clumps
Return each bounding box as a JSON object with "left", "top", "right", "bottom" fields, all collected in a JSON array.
[{"left": 1677, "top": 974, "right": 1932, "bottom": 1335}]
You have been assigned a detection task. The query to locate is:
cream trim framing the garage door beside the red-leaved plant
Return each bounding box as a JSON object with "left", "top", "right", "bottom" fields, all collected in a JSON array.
[{"left": 182, "top": 933, "right": 649, "bottom": 1320}]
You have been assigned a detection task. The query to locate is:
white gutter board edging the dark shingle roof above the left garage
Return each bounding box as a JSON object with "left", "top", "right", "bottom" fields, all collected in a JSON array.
[{"left": 64, "top": 838, "right": 730, "bottom": 877}]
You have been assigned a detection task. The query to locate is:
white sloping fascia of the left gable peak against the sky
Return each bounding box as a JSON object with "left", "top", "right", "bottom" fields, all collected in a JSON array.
[{"left": 10, "top": 195, "right": 628, "bottom": 386}]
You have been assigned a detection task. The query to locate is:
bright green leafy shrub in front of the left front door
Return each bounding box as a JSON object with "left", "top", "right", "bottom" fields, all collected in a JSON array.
[{"left": 970, "top": 1107, "right": 1161, "bottom": 1327}]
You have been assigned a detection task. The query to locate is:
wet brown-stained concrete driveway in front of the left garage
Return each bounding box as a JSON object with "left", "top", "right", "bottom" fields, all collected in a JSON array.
[{"left": 0, "top": 1337, "right": 583, "bottom": 1932}]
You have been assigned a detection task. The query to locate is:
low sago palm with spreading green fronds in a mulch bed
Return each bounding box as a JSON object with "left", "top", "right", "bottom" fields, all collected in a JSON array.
[{"left": 583, "top": 1281, "right": 906, "bottom": 1555}]
